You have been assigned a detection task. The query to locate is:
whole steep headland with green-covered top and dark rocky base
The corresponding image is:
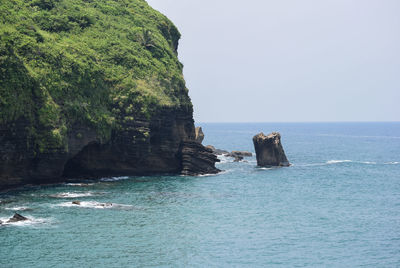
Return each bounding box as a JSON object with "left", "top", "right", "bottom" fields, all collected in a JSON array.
[{"left": 0, "top": 0, "right": 218, "bottom": 189}]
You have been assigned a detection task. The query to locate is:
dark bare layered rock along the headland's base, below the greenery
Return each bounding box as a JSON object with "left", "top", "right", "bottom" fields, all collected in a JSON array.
[{"left": 0, "top": 105, "right": 219, "bottom": 190}]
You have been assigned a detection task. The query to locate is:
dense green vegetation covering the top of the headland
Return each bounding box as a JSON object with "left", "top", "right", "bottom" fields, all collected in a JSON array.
[{"left": 0, "top": 0, "right": 191, "bottom": 152}]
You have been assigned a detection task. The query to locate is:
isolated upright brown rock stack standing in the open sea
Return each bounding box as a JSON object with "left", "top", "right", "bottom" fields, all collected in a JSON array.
[{"left": 253, "top": 132, "right": 290, "bottom": 167}]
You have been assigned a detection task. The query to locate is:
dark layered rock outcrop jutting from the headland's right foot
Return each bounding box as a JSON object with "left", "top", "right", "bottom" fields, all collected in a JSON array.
[{"left": 181, "top": 141, "right": 220, "bottom": 176}]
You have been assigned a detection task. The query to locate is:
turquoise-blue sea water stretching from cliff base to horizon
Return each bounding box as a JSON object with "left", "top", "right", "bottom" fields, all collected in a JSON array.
[{"left": 0, "top": 123, "right": 400, "bottom": 268}]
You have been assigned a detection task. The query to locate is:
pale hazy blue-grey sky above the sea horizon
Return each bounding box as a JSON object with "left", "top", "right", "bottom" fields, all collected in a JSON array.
[{"left": 148, "top": 0, "right": 400, "bottom": 122}]
